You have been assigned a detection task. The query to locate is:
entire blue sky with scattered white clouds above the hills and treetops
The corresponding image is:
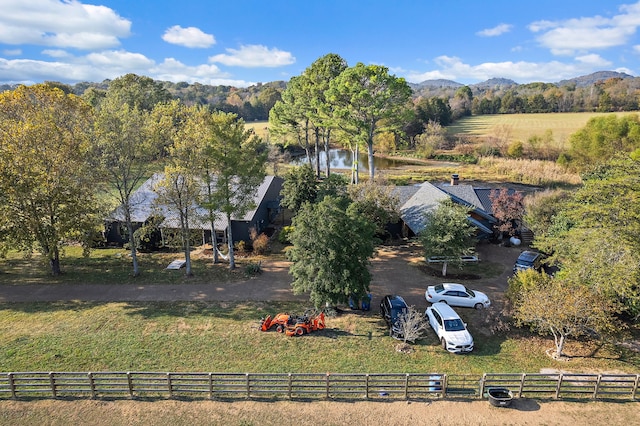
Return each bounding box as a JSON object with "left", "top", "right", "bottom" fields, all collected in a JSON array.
[{"left": 0, "top": 0, "right": 640, "bottom": 87}]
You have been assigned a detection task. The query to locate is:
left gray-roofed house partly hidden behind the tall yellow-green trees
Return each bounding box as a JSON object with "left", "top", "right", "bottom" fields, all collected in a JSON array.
[{"left": 105, "top": 173, "right": 283, "bottom": 244}]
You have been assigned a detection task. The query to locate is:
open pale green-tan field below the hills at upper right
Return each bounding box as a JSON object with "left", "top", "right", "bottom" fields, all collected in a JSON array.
[{"left": 447, "top": 112, "right": 633, "bottom": 146}]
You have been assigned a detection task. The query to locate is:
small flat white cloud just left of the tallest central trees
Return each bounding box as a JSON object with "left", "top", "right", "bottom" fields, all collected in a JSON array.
[{"left": 209, "top": 45, "right": 296, "bottom": 68}]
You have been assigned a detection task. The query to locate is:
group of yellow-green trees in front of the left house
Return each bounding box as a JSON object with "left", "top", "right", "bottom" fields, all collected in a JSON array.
[{"left": 0, "top": 74, "right": 267, "bottom": 276}]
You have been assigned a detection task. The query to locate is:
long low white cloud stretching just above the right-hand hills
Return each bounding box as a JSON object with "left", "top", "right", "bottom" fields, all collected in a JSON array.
[{"left": 406, "top": 55, "right": 607, "bottom": 84}]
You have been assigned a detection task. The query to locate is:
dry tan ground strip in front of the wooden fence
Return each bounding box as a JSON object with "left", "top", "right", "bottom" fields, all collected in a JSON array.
[{"left": 0, "top": 398, "right": 640, "bottom": 426}]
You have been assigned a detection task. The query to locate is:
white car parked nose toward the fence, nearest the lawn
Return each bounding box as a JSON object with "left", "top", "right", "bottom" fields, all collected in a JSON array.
[{"left": 425, "top": 302, "right": 473, "bottom": 354}]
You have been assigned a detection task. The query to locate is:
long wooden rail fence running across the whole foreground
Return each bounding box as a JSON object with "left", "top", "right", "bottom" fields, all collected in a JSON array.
[{"left": 0, "top": 371, "right": 640, "bottom": 401}]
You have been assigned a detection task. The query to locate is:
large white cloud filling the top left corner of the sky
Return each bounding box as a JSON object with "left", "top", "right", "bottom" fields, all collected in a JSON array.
[{"left": 0, "top": 0, "right": 131, "bottom": 50}]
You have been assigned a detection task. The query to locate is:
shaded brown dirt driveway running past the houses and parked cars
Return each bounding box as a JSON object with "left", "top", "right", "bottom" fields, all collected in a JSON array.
[{"left": 0, "top": 243, "right": 522, "bottom": 309}]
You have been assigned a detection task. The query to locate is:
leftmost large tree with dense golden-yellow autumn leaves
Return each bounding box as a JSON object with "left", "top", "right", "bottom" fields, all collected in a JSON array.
[{"left": 0, "top": 84, "right": 101, "bottom": 275}]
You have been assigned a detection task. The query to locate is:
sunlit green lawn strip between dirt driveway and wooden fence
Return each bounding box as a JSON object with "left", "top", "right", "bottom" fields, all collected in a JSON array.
[{"left": 0, "top": 302, "right": 640, "bottom": 374}]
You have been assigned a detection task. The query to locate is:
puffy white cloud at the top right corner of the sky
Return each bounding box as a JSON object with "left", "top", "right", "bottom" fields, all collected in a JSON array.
[{"left": 529, "top": 2, "right": 640, "bottom": 55}]
